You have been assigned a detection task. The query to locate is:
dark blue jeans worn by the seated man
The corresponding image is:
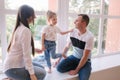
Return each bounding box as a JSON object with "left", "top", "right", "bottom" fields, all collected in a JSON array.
[{"left": 57, "top": 55, "right": 91, "bottom": 80}]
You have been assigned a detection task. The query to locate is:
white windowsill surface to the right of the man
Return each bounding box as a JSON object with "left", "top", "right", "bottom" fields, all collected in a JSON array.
[{"left": 92, "top": 53, "right": 120, "bottom": 72}]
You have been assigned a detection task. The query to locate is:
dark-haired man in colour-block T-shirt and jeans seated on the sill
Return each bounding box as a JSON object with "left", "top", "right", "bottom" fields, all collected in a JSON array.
[{"left": 57, "top": 14, "right": 94, "bottom": 80}]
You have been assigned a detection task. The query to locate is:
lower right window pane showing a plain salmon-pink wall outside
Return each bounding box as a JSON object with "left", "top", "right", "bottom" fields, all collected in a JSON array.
[{"left": 103, "top": 19, "right": 120, "bottom": 53}]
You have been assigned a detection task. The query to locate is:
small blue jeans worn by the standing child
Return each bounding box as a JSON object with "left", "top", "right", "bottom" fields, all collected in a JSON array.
[{"left": 44, "top": 40, "right": 62, "bottom": 68}]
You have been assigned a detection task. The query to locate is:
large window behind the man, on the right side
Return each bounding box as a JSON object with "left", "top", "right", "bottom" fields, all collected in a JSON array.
[{"left": 68, "top": 0, "right": 120, "bottom": 56}]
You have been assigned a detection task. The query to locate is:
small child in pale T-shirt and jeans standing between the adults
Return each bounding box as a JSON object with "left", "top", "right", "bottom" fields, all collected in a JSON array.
[{"left": 42, "top": 11, "right": 72, "bottom": 73}]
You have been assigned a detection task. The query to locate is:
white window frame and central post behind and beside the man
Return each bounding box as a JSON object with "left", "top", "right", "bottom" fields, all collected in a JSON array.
[{"left": 58, "top": 0, "right": 120, "bottom": 56}]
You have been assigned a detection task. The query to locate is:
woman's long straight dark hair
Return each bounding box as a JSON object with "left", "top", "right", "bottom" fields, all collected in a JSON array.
[{"left": 7, "top": 5, "right": 35, "bottom": 56}]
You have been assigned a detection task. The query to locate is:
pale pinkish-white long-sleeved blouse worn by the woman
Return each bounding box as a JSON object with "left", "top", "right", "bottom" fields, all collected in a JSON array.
[{"left": 4, "top": 24, "right": 34, "bottom": 74}]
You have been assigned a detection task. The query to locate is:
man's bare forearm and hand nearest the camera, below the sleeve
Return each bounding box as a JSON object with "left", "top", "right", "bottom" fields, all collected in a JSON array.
[{"left": 69, "top": 50, "right": 91, "bottom": 75}]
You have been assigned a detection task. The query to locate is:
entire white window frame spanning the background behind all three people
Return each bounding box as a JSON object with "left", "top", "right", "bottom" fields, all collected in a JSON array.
[{"left": 0, "top": 0, "right": 120, "bottom": 60}]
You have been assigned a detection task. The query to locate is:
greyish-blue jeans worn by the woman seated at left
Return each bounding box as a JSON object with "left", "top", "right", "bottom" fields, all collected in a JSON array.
[{"left": 5, "top": 62, "right": 46, "bottom": 80}]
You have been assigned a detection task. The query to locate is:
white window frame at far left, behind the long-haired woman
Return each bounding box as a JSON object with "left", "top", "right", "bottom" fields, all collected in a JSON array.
[{"left": 0, "top": 0, "right": 45, "bottom": 62}]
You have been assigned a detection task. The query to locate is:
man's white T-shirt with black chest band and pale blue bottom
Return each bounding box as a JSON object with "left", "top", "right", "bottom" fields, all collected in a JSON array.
[{"left": 68, "top": 29, "right": 94, "bottom": 59}]
